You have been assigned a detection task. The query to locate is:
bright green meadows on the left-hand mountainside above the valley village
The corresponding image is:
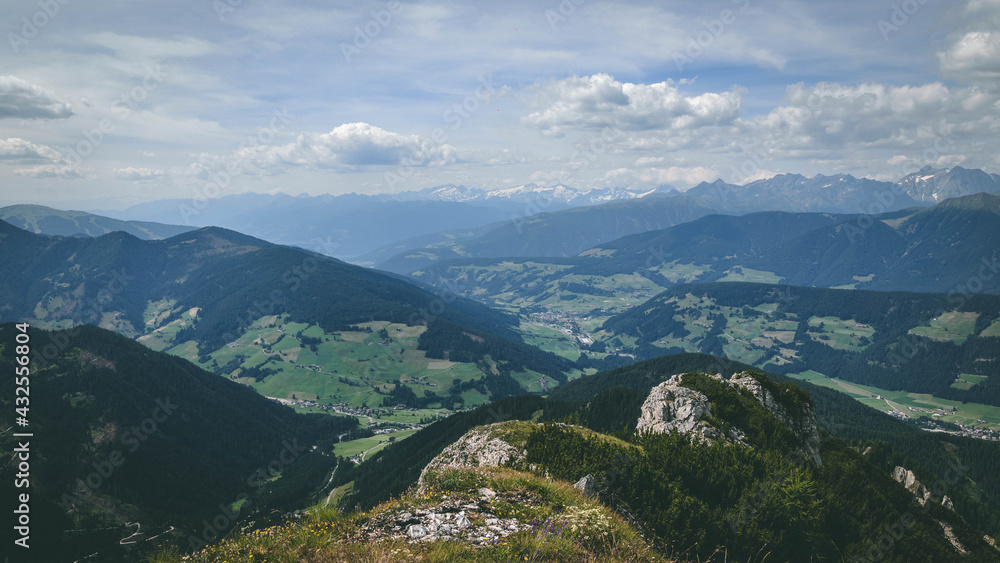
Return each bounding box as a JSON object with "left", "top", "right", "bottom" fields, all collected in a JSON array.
[{"left": 149, "top": 310, "right": 536, "bottom": 408}]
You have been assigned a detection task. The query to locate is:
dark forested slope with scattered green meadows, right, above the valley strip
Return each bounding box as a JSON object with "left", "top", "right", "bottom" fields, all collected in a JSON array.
[{"left": 602, "top": 283, "right": 1000, "bottom": 405}]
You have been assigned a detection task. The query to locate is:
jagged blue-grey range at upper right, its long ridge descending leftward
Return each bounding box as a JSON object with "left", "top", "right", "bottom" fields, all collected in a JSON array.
[{"left": 372, "top": 167, "right": 1000, "bottom": 273}]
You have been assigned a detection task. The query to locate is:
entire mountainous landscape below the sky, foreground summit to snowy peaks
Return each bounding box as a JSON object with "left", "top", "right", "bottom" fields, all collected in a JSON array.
[{"left": 0, "top": 167, "right": 1000, "bottom": 563}]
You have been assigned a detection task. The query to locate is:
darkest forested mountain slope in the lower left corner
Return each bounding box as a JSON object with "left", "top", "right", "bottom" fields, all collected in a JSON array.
[{"left": 0, "top": 323, "right": 357, "bottom": 561}]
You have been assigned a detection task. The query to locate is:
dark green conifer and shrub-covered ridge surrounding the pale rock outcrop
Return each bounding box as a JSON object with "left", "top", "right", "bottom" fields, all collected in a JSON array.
[{"left": 318, "top": 354, "right": 1000, "bottom": 561}]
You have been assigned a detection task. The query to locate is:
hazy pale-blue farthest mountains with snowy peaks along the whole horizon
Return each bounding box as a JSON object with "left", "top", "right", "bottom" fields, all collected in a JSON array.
[{"left": 0, "top": 167, "right": 1000, "bottom": 271}]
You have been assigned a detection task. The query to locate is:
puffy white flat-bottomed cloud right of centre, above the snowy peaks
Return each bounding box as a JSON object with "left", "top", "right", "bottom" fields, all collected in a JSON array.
[{"left": 522, "top": 74, "right": 745, "bottom": 136}]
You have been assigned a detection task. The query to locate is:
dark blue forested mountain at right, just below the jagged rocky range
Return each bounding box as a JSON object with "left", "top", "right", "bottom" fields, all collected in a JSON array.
[{"left": 412, "top": 194, "right": 1000, "bottom": 332}]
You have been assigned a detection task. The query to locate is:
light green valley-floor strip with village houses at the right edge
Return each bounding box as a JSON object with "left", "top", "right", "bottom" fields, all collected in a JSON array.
[{"left": 790, "top": 371, "right": 1000, "bottom": 431}]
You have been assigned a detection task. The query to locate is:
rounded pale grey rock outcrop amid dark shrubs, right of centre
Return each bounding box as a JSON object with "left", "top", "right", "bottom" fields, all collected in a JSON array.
[{"left": 636, "top": 375, "right": 747, "bottom": 446}]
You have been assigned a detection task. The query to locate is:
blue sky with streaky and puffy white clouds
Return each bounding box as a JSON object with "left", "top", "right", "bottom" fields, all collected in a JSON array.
[{"left": 0, "top": 0, "right": 1000, "bottom": 209}]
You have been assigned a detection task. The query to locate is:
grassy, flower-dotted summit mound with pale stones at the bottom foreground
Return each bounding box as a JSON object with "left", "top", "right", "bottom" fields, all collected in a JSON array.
[{"left": 150, "top": 468, "right": 666, "bottom": 563}]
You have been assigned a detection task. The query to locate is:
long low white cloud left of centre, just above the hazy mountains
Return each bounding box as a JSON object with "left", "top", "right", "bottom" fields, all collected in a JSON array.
[{"left": 195, "top": 123, "right": 459, "bottom": 173}]
